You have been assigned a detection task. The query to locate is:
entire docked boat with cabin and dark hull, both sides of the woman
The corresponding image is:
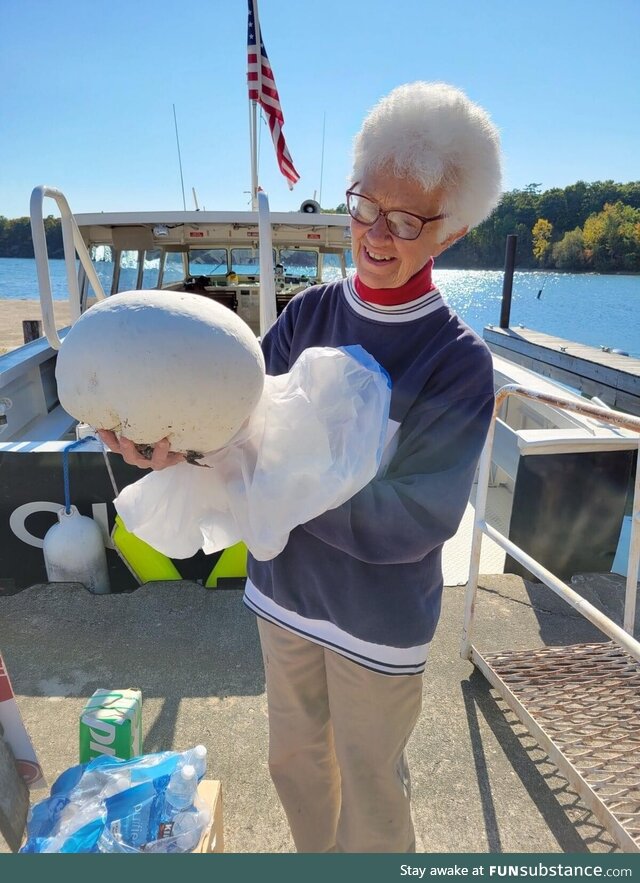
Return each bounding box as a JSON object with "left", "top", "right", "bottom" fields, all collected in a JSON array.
[{"left": 0, "top": 186, "right": 638, "bottom": 593}]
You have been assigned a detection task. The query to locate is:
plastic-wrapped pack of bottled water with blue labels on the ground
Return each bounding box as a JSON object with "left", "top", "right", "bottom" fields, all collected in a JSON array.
[{"left": 20, "top": 745, "right": 211, "bottom": 853}]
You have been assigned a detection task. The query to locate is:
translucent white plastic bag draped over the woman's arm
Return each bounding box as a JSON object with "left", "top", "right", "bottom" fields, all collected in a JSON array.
[{"left": 115, "top": 346, "right": 391, "bottom": 561}]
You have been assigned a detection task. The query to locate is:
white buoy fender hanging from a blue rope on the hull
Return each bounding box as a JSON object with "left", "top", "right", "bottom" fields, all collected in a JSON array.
[{"left": 43, "top": 506, "right": 111, "bottom": 595}]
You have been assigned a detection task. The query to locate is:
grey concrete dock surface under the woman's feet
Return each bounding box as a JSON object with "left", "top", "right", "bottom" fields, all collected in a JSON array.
[{"left": 0, "top": 575, "right": 636, "bottom": 853}]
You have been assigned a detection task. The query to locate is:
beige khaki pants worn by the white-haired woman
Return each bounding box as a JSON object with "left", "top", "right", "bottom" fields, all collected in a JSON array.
[{"left": 258, "top": 618, "right": 422, "bottom": 852}]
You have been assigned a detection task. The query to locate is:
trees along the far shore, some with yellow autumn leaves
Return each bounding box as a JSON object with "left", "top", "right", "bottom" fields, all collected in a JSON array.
[{"left": 0, "top": 181, "right": 640, "bottom": 273}]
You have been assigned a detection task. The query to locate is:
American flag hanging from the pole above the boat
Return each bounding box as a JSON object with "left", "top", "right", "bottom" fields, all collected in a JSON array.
[{"left": 247, "top": 0, "right": 300, "bottom": 190}]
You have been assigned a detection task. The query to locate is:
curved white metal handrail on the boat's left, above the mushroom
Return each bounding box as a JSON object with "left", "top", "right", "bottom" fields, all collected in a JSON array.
[{"left": 29, "top": 184, "right": 106, "bottom": 350}]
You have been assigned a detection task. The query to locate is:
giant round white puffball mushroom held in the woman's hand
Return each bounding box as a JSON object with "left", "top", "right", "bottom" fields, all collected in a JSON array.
[{"left": 56, "top": 290, "right": 265, "bottom": 457}]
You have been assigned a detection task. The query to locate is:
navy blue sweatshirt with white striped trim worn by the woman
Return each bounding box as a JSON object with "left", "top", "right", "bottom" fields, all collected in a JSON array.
[{"left": 244, "top": 279, "right": 493, "bottom": 675}]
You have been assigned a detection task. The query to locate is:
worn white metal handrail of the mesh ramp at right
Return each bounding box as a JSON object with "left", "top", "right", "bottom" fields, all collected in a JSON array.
[{"left": 460, "top": 384, "right": 640, "bottom": 661}]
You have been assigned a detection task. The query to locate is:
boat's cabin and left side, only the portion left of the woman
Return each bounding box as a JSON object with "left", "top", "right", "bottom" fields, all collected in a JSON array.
[{"left": 0, "top": 186, "right": 351, "bottom": 594}]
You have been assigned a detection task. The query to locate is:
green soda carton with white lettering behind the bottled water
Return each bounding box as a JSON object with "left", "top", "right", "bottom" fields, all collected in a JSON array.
[{"left": 80, "top": 690, "right": 142, "bottom": 763}]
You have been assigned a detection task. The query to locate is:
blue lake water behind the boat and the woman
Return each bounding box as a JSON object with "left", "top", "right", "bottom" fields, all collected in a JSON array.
[{"left": 0, "top": 258, "right": 640, "bottom": 358}]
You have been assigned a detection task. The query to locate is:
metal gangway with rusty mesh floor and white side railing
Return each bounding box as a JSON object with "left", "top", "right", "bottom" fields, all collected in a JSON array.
[{"left": 460, "top": 385, "right": 640, "bottom": 852}]
